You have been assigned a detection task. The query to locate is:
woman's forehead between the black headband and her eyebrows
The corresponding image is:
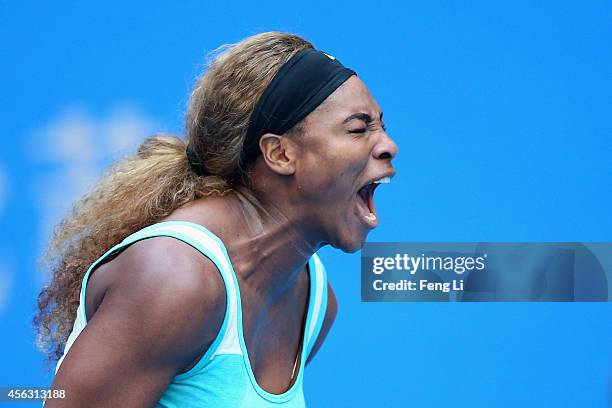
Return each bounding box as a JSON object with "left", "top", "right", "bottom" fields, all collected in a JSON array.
[{"left": 307, "top": 75, "right": 380, "bottom": 123}]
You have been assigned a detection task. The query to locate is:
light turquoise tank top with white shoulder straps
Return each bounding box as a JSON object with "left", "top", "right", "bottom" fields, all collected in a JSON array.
[{"left": 56, "top": 221, "right": 327, "bottom": 408}]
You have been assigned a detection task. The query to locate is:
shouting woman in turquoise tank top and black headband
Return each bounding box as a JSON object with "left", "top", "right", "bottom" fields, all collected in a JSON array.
[{"left": 35, "top": 32, "right": 397, "bottom": 408}]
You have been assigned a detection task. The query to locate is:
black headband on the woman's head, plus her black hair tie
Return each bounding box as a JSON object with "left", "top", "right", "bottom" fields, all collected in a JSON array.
[{"left": 187, "top": 48, "right": 357, "bottom": 176}]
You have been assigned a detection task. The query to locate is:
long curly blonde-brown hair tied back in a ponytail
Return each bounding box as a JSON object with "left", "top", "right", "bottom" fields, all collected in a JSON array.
[{"left": 33, "top": 32, "right": 313, "bottom": 362}]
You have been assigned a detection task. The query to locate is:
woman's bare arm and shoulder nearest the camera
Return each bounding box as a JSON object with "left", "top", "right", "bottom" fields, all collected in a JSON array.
[{"left": 45, "top": 237, "right": 226, "bottom": 408}]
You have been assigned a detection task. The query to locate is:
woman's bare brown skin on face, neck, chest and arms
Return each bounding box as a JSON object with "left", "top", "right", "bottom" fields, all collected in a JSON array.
[{"left": 46, "top": 76, "right": 397, "bottom": 408}]
